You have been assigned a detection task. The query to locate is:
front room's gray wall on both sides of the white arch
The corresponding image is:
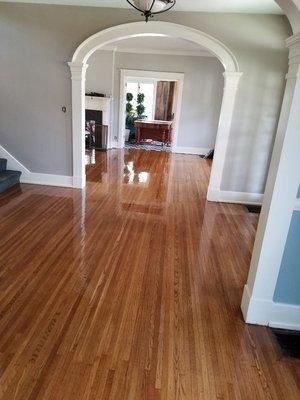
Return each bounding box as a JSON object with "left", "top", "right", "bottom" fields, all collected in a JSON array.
[{"left": 0, "top": 3, "right": 291, "bottom": 192}]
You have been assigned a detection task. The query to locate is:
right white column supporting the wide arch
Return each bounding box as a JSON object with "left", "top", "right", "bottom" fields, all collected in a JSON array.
[{"left": 207, "top": 72, "right": 242, "bottom": 201}]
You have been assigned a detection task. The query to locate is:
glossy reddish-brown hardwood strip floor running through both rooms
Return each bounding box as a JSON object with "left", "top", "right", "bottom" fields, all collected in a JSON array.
[{"left": 0, "top": 150, "right": 300, "bottom": 400}]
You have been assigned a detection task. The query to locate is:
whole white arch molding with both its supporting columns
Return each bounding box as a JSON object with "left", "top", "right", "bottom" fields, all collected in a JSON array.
[{"left": 69, "top": 21, "right": 242, "bottom": 190}]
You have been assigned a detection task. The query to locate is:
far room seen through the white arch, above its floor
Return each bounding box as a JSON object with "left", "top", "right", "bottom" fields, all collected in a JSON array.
[{"left": 85, "top": 36, "right": 224, "bottom": 169}]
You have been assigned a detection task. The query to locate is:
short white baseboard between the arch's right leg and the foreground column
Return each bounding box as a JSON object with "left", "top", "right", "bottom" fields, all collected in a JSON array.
[{"left": 207, "top": 189, "right": 263, "bottom": 205}]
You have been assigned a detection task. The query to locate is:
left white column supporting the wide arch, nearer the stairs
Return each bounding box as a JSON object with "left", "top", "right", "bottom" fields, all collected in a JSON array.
[{"left": 68, "top": 62, "right": 88, "bottom": 189}]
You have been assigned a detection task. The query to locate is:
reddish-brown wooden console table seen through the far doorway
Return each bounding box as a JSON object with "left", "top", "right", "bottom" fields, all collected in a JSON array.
[{"left": 134, "top": 119, "right": 172, "bottom": 145}]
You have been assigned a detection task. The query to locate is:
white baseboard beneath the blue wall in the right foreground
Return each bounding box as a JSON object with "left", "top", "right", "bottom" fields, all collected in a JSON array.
[{"left": 241, "top": 285, "right": 300, "bottom": 331}]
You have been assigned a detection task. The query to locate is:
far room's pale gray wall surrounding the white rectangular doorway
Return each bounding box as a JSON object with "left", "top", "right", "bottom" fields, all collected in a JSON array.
[{"left": 86, "top": 51, "right": 224, "bottom": 148}]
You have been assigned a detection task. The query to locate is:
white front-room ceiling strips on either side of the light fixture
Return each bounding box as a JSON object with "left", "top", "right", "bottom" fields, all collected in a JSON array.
[{"left": 1, "top": 0, "right": 282, "bottom": 14}]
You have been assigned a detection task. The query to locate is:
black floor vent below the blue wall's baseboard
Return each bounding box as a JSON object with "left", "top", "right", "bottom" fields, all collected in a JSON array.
[{"left": 271, "top": 328, "right": 300, "bottom": 359}]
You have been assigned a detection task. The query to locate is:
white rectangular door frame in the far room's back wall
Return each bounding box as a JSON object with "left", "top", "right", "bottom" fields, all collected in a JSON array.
[{"left": 118, "top": 69, "right": 184, "bottom": 152}]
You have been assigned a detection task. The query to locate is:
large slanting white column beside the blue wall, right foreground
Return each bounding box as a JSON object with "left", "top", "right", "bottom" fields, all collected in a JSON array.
[{"left": 242, "top": 34, "right": 300, "bottom": 325}]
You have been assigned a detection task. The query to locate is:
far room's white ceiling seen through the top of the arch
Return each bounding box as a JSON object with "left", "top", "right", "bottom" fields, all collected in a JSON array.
[{"left": 102, "top": 36, "right": 212, "bottom": 57}]
